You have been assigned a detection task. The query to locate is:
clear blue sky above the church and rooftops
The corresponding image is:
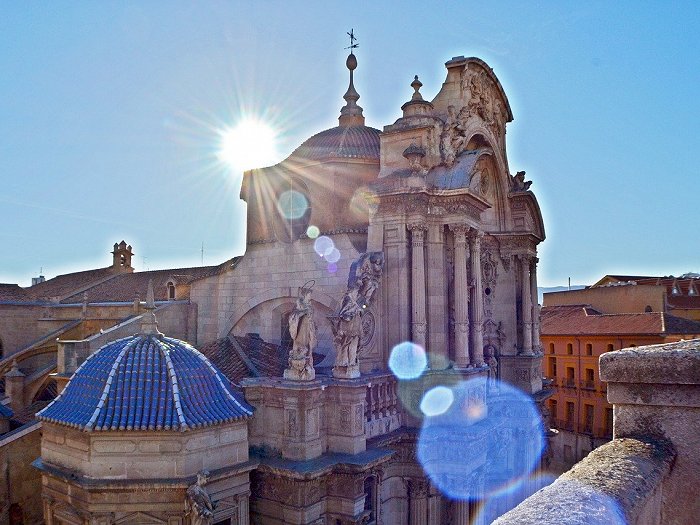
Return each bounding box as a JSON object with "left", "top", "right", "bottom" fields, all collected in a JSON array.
[{"left": 0, "top": 1, "right": 700, "bottom": 286}]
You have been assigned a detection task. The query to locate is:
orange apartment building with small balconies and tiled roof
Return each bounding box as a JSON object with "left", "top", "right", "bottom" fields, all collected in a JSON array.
[{"left": 540, "top": 276, "right": 700, "bottom": 469}]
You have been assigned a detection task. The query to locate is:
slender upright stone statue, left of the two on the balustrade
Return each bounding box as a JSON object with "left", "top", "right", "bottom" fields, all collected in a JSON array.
[{"left": 284, "top": 281, "right": 317, "bottom": 381}]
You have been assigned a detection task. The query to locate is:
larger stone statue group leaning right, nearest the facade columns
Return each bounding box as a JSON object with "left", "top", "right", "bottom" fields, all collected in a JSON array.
[{"left": 329, "top": 252, "right": 384, "bottom": 379}]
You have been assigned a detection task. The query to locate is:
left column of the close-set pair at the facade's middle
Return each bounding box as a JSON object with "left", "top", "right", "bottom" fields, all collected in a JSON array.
[{"left": 450, "top": 224, "right": 470, "bottom": 368}]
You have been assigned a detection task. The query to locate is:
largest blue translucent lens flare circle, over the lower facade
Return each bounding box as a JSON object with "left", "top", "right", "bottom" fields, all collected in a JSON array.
[{"left": 417, "top": 377, "right": 546, "bottom": 500}]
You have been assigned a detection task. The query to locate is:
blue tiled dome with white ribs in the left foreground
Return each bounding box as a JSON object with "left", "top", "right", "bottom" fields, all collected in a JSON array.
[{"left": 37, "top": 335, "right": 253, "bottom": 431}]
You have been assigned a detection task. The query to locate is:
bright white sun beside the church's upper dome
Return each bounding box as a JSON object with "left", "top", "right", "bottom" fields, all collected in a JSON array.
[{"left": 219, "top": 119, "right": 277, "bottom": 171}]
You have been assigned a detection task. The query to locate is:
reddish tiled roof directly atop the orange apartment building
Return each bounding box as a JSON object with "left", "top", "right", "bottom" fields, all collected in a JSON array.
[{"left": 540, "top": 305, "right": 700, "bottom": 335}]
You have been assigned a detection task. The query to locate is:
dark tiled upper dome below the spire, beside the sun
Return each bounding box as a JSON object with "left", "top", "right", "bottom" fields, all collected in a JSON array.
[{"left": 291, "top": 126, "right": 381, "bottom": 160}]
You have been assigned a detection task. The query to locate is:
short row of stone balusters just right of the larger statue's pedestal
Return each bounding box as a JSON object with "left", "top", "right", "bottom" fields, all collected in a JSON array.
[{"left": 365, "top": 374, "right": 401, "bottom": 439}]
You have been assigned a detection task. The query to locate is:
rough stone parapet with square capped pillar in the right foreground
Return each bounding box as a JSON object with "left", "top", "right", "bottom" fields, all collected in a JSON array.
[{"left": 494, "top": 339, "right": 700, "bottom": 525}]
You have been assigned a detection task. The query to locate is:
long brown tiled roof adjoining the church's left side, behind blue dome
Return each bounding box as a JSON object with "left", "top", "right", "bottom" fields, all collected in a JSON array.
[{"left": 59, "top": 260, "right": 232, "bottom": 304}]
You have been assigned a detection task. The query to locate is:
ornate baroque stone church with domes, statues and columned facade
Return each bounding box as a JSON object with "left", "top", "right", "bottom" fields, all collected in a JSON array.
[{"left": 0, "top": 45, "right": 549, "bottom": 525}]
